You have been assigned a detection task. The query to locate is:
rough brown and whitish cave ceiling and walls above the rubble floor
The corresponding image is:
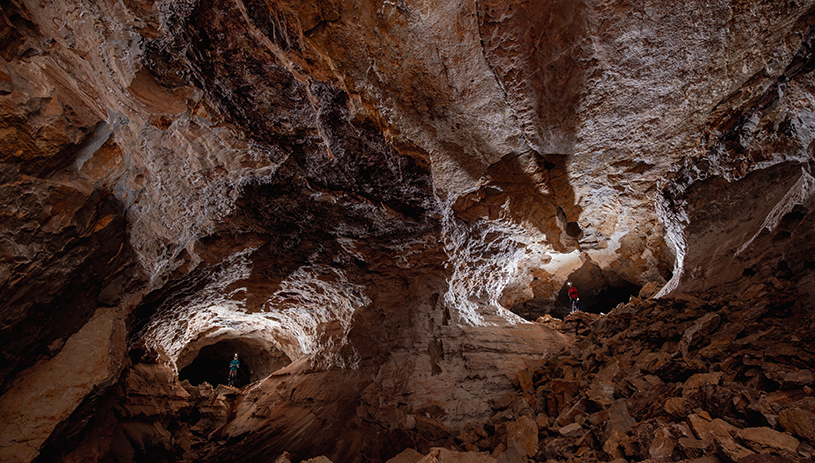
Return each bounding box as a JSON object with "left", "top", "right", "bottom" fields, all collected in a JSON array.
[{"left": 0, "top": 0, "right": 815, "bottom": 461}]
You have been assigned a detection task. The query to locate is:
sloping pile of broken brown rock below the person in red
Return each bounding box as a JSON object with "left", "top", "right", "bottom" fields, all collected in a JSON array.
[{"left": 292, "top": 279, "right": 815, "bottom": 463}]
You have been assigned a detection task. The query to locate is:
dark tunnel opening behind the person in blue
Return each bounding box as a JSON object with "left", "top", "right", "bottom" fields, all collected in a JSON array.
[{"left": 178, "top": 338, "right": 291, "bottom": 387}]
